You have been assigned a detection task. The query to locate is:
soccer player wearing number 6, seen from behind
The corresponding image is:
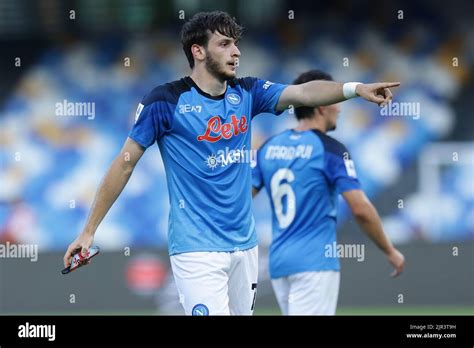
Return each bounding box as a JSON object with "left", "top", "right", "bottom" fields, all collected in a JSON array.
[{"left": 252, "top": 70, "right": 404, "bottom": 315}]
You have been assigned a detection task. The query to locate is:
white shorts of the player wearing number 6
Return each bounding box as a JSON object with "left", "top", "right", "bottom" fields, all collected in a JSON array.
[{"left": 272, "top": 271, "right": 340, "bottom": 315}]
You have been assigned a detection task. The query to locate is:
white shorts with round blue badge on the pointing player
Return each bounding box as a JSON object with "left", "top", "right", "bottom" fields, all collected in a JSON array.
[{"left": 171, "top": 247, "right": 258, "bottom": 315}]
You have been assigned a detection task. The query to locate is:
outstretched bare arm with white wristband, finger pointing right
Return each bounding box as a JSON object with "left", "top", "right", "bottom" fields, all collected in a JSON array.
[{"left": 276, "top": 81, "right": 400, "bottom": 111}]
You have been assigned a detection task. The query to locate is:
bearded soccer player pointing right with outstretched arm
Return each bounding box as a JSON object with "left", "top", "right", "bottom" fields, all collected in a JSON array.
[{"left": 64, "top": 11, "right": 399, "bottom": 315}]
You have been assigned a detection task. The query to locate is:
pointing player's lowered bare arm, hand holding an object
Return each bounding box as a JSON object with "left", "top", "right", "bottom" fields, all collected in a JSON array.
[{"left": 64, "top": 138, "right": 144, "bottom": 267}]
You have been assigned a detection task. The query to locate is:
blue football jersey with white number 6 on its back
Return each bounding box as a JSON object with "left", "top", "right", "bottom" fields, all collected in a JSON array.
[{"left": 252, "top": 130, "right": 360, "bottom": 278}]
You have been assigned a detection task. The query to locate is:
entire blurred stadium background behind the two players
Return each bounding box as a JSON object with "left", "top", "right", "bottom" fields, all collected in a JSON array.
[{"left": 0, "top": 0, "right": 474, "bottom": 314}]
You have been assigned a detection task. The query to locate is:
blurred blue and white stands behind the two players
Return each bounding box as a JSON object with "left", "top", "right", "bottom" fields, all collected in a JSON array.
[{"left": 0, "top": 10, "right": 474, "bottom": 250}]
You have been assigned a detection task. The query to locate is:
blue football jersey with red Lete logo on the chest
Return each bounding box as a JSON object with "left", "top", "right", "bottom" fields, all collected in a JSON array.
[{"left": 129, "top": 77, "right": 286, "bottom": 255}]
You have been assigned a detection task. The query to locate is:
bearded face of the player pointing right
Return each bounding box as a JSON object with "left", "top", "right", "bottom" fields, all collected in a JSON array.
[{"left": 206, "top": 31, "right": 240, "bottom": 81}]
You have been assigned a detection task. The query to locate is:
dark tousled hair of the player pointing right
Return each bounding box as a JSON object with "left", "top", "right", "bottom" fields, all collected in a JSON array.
[{"left": 181, "top": 11, "right": 243, "bottom": 69}]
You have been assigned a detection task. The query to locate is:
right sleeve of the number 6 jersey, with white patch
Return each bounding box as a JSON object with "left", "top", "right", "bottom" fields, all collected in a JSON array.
[{"left": 324, "top": 143, "right": 361, "bottom": 194}]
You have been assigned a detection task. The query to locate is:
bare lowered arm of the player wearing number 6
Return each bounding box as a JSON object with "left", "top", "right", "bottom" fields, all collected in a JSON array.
[{"left": 342, "top": 190, "right": 405, "bottom": 277}]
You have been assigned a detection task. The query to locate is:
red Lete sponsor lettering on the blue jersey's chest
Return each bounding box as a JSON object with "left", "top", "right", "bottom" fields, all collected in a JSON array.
[{"left": 197, "top": 115, "right": 249, "bottom": 143}]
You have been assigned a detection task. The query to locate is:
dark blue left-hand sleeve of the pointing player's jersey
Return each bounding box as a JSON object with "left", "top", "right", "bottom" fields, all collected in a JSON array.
[{"left": 128, "top": 87, "right": 173, "bottom": 149}]
